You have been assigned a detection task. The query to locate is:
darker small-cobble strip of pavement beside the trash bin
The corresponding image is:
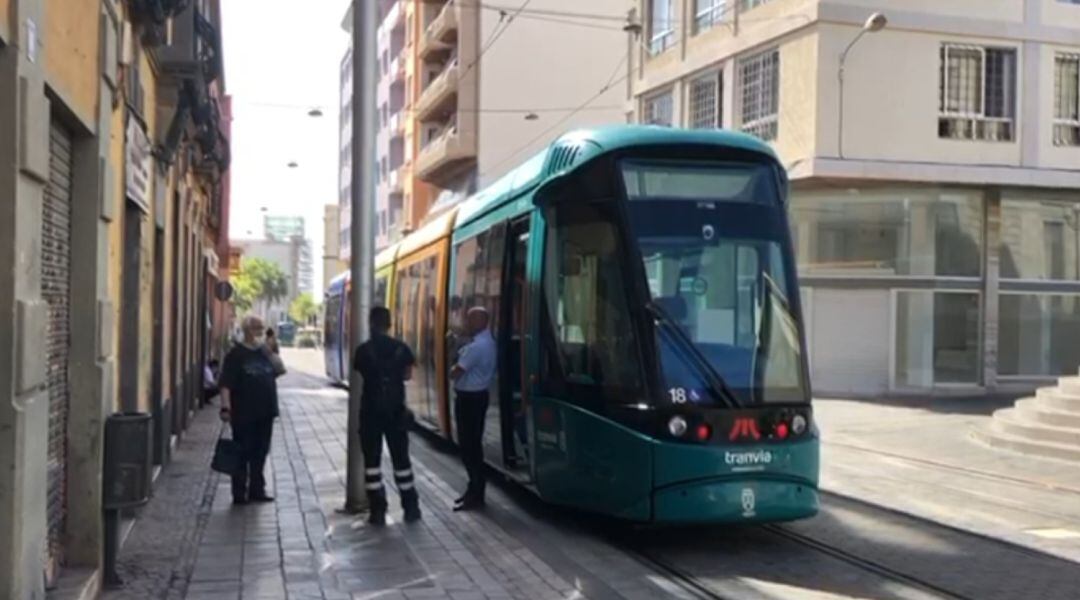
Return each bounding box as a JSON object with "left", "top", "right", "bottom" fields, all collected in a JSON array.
[{"left": 104, "top": 408, "right": 220, "bottom": 600}]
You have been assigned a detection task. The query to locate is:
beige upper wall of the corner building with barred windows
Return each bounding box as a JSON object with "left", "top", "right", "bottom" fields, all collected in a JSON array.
[{"left": 633, "top": 0, "right": 1080, "bottom": 180}]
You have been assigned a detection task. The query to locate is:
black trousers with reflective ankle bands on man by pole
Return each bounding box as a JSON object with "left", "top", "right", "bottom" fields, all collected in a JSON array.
[{"left": 360, "top": 412, "right": 418, "bottom": 510}]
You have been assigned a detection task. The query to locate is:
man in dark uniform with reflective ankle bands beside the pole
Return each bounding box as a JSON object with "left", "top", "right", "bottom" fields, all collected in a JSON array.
[{"left": 353, "top": 306, "right": 420, "bottom": 526}]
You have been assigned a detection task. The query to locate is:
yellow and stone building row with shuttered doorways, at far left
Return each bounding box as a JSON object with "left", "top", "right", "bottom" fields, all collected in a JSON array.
[{"left": 0, "top": 0, "right": 229, "bottom": 599}]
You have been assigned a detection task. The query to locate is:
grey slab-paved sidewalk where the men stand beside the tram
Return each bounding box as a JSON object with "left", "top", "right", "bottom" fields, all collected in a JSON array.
[{"left": 174, "top": 352, "right": 664, "bottom": 600}]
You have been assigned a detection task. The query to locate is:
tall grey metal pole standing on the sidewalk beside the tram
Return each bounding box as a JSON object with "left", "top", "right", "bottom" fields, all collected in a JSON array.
[{"left": 343, "top": 0, "right": 378, "bottom": 514}]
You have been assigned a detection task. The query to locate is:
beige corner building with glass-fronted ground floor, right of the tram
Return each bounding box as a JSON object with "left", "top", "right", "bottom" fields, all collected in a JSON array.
[{"left": 630, "top": 0, "right": 1080, "bottom": 395}]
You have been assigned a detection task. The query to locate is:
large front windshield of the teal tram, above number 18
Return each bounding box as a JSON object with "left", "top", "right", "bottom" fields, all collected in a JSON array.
[{"left": 622, "top": 162, "right": 809, "bottom": 406}]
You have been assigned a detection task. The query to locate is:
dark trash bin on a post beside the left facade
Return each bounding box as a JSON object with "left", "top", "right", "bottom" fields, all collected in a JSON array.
[{"left": 102, "top": 412, "right": 153, "bottom": 510}]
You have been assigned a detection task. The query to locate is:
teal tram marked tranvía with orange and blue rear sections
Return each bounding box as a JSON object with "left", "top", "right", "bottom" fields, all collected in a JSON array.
[{"left": 326, "top": 125, "right": 819, "bottom": 524}]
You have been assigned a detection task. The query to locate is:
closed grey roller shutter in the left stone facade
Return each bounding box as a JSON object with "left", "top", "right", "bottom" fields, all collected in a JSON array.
[{"left": 41, "top": 122, "right": 71, "bottom": 582}]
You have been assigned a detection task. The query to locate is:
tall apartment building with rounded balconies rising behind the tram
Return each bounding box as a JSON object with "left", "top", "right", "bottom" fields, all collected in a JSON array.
[{"left": 339, "top": 0, "right": 634, "bottom": 258}]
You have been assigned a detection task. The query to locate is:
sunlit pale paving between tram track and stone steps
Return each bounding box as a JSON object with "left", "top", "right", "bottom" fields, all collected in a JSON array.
[{"left": 814, "top": 398, "right": 1080, "bottom": 561}]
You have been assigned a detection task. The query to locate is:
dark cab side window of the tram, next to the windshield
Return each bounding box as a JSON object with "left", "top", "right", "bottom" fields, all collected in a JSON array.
[{"left": 544, "top": 202, "right": 643, "bottom": 401}]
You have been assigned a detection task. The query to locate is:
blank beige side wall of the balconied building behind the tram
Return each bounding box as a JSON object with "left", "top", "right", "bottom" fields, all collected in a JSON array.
[{"left": 477, "top": 0, "right": 635, "bottom": 187}]
